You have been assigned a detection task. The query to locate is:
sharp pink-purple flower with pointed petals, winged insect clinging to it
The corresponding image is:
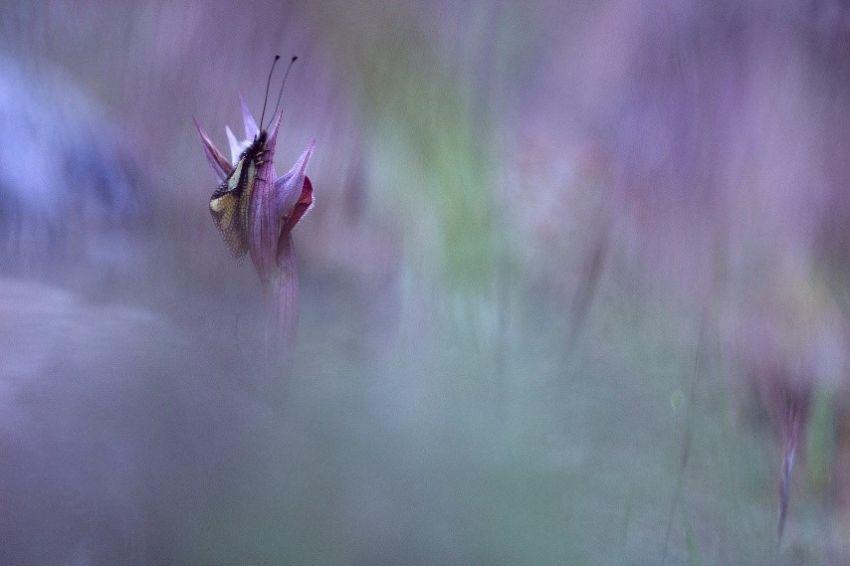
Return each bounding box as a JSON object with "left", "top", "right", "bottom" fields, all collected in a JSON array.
[{"left": 195, "top": 97, "right": 315, "bottom": 352}]
